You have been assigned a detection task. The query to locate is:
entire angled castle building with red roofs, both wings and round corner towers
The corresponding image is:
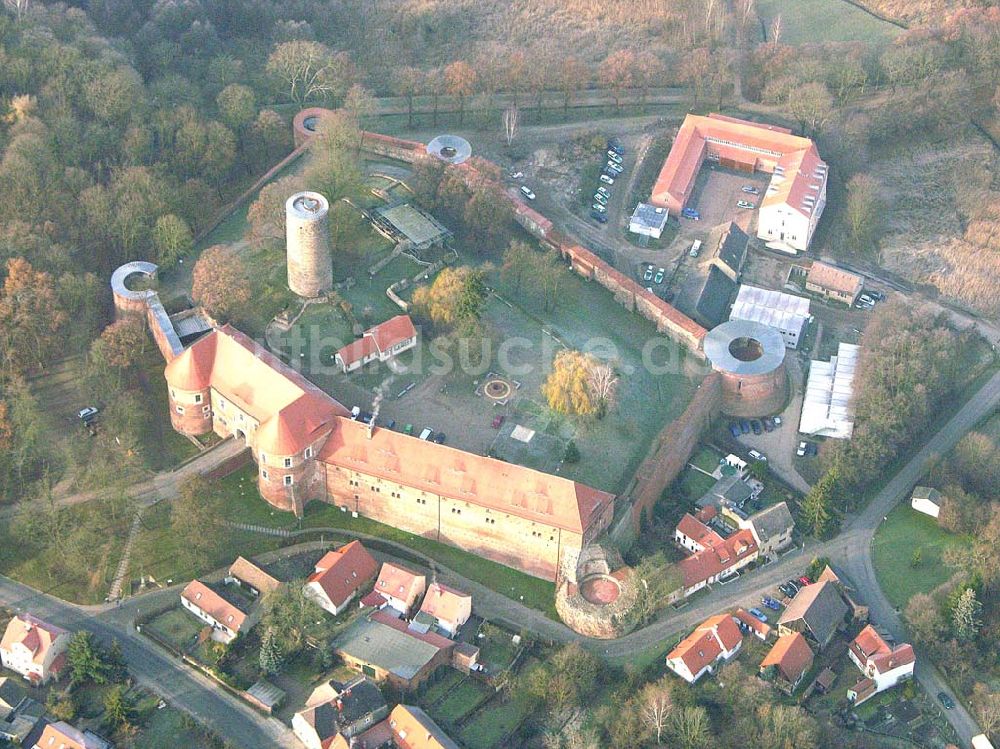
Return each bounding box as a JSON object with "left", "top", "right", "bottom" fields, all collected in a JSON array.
[{"left": 165, "top": 326, "right": 614, "bottom": 580}]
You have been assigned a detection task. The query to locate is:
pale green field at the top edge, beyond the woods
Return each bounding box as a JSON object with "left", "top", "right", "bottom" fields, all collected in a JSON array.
[{"left": 757, "top": 0, "right": 901, "bottom": 44}]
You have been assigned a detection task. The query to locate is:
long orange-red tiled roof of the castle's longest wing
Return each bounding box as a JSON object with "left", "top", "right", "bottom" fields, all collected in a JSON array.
[{"left": 319, "top": 419, "right": 614, "bottom": 533}]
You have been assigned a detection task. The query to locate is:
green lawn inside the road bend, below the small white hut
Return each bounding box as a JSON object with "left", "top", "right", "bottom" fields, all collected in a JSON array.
[{"left": 873, "top": 502, "right": 967, "bottom": 609}]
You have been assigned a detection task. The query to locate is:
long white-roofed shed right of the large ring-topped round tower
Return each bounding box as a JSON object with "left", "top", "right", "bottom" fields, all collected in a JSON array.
[{"left": 799, "top": 343, "right": 861, "bottom": 439}]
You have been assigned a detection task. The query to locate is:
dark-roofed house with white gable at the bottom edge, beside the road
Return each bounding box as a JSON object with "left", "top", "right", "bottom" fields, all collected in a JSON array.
[{"left": 292, "top": 676, "right": 389, "bottom": 749}]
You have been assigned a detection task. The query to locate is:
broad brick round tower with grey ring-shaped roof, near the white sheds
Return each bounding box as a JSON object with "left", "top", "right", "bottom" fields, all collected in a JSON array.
[{"left": 703, "top": 320, "right": 788, "bottom": 417}]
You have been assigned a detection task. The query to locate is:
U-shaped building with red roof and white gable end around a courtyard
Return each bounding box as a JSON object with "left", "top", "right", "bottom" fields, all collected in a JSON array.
[{"left": 649, "top": 114, "right": 828, "bottom": 254}]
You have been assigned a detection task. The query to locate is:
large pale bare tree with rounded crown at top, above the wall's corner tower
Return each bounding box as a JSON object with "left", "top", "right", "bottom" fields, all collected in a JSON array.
[{"left": 265, "top": 41, "right": 354, "bottom": 106}]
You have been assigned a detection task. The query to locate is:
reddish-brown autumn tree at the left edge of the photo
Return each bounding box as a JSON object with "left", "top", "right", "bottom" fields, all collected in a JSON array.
[{"left": 0, "top": 258, "right": 67, "bottom": 375}]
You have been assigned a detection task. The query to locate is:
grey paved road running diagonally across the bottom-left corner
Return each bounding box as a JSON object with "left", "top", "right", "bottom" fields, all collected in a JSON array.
[{"left": 0, "top": 576, "right": 300, "bottom": 749}]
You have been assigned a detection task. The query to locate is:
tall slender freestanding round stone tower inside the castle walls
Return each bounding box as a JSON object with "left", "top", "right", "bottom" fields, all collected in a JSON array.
[{"left": 285, "top": 192, "right": 333, "bottom": 299}]
